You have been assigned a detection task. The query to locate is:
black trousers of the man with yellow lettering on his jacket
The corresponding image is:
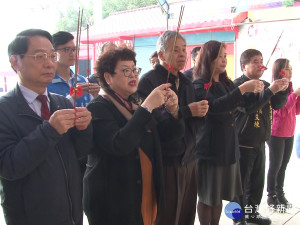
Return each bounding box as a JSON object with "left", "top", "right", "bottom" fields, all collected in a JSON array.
[{"left": 235, "top": 142, "right": 266, "bottom": 213}]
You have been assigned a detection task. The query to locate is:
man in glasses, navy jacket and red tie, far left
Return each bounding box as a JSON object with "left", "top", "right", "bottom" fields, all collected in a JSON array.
[{"left": 0, "top": 29, "right": 92, "bottom": 225}]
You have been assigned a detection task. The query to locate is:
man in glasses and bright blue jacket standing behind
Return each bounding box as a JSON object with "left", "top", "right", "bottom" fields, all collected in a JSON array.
[{"left": 47, "top": 31, "right": 100, "bottom": 107}]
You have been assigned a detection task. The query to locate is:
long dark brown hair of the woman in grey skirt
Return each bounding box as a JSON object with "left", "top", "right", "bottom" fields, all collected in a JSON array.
[{"left": 194, "top": 40, "right": 232, "bottom": 86}]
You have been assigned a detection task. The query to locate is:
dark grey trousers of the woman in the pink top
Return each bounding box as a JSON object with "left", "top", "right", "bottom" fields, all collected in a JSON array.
[{"left": 267, "top": 136, "right": 294, "bottom": 196}]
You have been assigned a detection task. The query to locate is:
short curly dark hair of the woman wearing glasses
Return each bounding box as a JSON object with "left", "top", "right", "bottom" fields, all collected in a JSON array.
[{"left": 96, "top": 47, "right": 136, "bottom": 88}]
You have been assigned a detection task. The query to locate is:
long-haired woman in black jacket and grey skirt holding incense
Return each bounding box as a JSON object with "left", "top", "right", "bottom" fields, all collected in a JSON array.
[{"left": 193, "top": 41, "right": 263, "bottom": 225}]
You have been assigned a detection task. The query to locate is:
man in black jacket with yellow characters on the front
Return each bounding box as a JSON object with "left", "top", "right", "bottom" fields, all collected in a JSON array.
[{"left": 234, "top": 49, "right": 289, "bottom": 225}]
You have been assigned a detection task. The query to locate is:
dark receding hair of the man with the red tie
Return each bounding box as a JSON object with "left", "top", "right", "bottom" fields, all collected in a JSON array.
[{"left": 7, "top": 29, "right": 52, "bottom": 58}]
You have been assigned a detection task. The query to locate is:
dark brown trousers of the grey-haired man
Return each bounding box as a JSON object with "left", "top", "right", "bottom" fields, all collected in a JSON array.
[{"left": 154, "top": 162, "right": 197, "bottom": 225}]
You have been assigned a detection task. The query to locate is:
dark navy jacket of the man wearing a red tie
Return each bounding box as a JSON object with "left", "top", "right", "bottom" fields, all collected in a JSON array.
[{"left": 0, "top": 86, "right": 92, "bottom": 225}]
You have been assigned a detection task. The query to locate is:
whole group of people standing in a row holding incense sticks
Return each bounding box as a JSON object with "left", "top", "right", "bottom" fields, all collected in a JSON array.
[{"left": 0, "top": 29, "right": 300, "bottom": 225}]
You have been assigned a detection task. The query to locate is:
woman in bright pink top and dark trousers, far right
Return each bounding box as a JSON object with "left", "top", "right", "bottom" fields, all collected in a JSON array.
[{"left": 267, "top": 59, "right": 300, "bottom": 209}]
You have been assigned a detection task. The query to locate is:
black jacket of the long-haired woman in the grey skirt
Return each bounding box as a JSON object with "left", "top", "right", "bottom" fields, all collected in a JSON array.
[{"left": 193, "top": 79, "right": 244, "bottom": 166}]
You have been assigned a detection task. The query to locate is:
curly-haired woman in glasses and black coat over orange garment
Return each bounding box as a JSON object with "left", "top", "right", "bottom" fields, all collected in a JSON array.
[{"left": 83, "top": 48, "right": 184, "bottom": 225}]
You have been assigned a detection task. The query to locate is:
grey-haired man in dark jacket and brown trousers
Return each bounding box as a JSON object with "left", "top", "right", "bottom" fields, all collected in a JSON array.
[{"left": 138, "top": 31, "right": 208, "bottom": 225}]
